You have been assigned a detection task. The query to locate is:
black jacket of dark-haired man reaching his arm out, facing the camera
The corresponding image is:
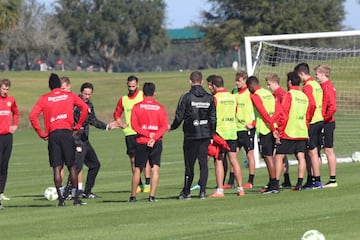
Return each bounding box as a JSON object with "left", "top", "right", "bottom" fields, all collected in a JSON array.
[{"left": 74, "top": 98, "right": 107, "bottom": 142}]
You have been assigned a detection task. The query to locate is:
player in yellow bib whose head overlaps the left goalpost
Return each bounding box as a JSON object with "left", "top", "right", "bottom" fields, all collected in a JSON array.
[{"left": 246, "top": 76, "right": 279, "bottom": 194}]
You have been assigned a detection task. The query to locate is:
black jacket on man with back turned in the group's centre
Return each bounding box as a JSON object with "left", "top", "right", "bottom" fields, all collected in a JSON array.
[{"left": 170, "top": 85, "right": 216, "bottom": 139}]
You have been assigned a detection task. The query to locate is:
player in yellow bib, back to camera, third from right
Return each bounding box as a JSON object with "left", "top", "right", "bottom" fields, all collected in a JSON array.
[{"left": 275, "top": 72, "right": 311, "bottom": 191}]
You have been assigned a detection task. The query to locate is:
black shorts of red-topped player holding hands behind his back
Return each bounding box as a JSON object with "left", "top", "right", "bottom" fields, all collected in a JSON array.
[{"left": 135, "top": 141, "right": 162, "bottom": 168}]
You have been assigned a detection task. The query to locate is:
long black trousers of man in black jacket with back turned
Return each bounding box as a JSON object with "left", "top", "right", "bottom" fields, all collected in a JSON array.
[{"left": 183, "top": 138, "right": 210, "bottom": 194}]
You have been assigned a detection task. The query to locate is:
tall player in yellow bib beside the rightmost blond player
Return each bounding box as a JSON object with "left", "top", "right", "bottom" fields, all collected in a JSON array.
[{"left": 294, "top": 63, "right": 324, "bottom": 189}]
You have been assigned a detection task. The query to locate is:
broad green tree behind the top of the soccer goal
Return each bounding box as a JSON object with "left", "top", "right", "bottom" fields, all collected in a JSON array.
[{"left": 203, "top": 0, "right": 345, "bottom": 51}]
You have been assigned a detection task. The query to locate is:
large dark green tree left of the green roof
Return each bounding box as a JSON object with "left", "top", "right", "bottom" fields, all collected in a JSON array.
[{"left": 55, "top": 0, "right": 168, "bottom": 72}]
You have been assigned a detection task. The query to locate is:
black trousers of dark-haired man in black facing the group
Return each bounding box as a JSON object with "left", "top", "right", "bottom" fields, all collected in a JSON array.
[{"left": 69, "top": 140, "right": 100, "bottom": 194}]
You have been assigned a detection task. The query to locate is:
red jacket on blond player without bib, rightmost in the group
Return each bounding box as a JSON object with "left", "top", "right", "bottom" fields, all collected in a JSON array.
[{"left": 320, "top": 79, "right": 336, "bottom": 122}]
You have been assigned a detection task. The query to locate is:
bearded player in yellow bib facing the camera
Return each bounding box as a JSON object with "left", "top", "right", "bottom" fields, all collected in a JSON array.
[{"left": 114, "top": 75, "right": 151, "bottom": 193}]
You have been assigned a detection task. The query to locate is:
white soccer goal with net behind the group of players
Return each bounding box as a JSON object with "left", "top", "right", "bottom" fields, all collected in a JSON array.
[{"left": 245, "top": 31, "right": 360, "bottom": 166}]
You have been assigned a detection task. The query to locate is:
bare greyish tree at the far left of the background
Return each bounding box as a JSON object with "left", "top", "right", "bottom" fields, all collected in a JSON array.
[{"left": 1, "top": 0, "right": 66, "bottom": 70}]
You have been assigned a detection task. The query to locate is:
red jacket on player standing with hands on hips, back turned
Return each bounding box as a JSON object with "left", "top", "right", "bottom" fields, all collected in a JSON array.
[{"left": 30, "top": 88, "right": 88, "bottom": 138}]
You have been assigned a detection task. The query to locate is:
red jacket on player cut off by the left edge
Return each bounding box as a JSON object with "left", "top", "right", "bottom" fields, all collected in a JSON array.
[{"left": 0, "top": 96, "right": 19, "bottom": 134}]
